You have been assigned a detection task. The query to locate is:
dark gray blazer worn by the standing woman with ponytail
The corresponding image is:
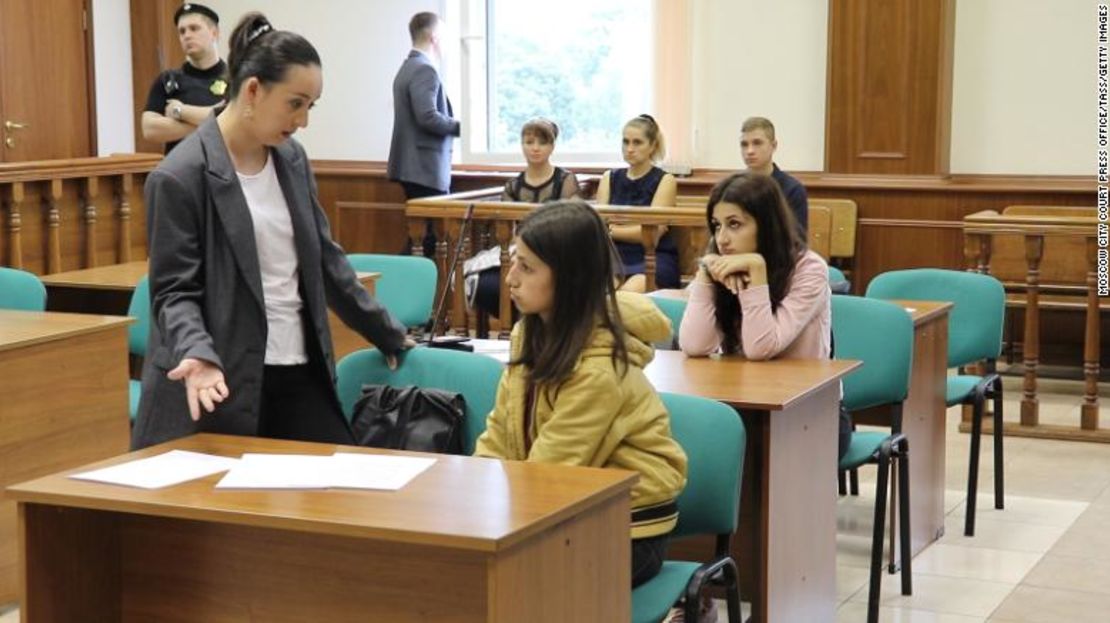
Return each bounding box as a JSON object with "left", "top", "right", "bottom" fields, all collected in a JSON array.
[{"left": 131, "top": 117, "right": 404, "bottom": 449}]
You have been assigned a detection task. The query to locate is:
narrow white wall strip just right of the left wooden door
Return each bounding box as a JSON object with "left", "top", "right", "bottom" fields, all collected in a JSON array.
[{"left": 92, "top": 0, "right": 135, "bottom": 155}]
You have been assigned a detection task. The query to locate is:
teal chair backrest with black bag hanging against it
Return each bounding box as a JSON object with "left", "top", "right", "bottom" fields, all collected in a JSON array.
[{"left": 335, "top": 346, "right": 504, "bottom": 454}]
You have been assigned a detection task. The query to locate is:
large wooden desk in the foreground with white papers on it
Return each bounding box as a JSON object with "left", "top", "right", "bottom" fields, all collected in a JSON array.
[{"left": 8, "top": 435, "right": 636, "bottom": 623}]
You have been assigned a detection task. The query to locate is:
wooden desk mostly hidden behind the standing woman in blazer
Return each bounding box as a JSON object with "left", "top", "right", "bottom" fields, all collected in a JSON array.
[{"left": 41, "top": 260, "right": 382, "bottom": 361}]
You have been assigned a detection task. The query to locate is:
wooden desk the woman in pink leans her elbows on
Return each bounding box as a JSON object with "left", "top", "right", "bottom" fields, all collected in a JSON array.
[{"left": 646, "top": 351, "right": 860, "bottom": 622}]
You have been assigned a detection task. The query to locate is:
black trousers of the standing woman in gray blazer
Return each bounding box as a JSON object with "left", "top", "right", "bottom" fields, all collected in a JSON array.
[{"left": 259, "top": 362, "right": 354, "bottom": 445}]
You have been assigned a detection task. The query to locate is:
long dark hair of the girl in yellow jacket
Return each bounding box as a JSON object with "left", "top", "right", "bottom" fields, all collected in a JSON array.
[{"left": 509, "top": 200, "right": 628, "bottom": 393}]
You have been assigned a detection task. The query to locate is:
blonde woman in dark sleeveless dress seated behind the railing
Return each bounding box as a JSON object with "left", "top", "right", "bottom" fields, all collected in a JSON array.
[{"left": 597, "top": 114, "right": 680, "bottom": 292}]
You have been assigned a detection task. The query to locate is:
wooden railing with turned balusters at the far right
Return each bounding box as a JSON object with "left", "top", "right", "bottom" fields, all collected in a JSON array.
[{"left": 963, "top": 207, "right": 1110, "bottom": 442}]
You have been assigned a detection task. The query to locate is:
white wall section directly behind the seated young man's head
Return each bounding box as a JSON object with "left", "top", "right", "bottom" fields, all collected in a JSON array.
[{"left": 692, "top": 0, "right": 828, "bottom": 171}]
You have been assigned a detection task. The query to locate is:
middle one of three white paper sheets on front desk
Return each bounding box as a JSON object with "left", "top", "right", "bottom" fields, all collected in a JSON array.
[{"left": 215, "top": 453, "right": 332, "bottom": 489}]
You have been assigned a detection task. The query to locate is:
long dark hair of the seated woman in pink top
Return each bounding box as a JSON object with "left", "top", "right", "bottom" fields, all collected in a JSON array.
[{"left": 705, "top": 171, "right": 806, "bottom": 353}]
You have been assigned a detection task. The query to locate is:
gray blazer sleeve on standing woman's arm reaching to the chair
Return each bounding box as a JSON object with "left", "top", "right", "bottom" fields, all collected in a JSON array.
[{"left": 299, "top": 152, "right": 405, "bottom": 354}]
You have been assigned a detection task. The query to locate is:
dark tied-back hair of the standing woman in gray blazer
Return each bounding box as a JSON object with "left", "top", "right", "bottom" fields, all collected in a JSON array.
[{"left": 228, "top": 11, "right": 321, "bottom": 100}]
